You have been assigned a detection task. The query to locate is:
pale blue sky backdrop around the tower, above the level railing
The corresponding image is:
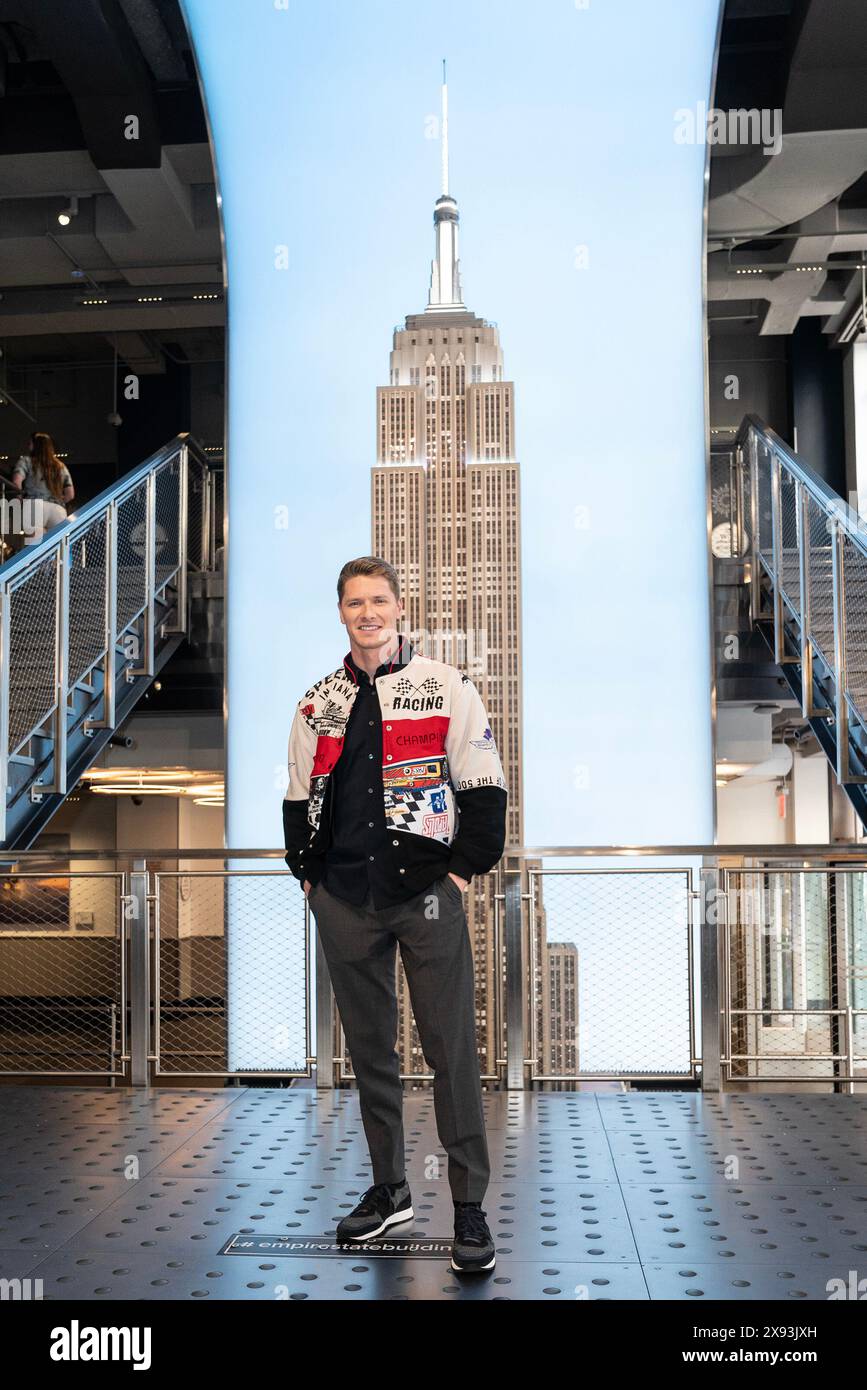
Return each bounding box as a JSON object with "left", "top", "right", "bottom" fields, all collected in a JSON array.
[{"left": 183, "top": 0, "right": 718, "bottom": 844}]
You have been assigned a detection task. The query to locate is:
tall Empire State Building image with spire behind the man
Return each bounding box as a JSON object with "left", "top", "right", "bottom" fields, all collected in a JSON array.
[{"left": 371, "top": 82, "right": 524, "bottom": 1077}]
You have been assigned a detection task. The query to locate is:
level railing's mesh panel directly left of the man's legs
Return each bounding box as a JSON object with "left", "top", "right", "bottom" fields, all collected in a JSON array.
[{"left": 154, "top": 870, "right": 310, "bottom": 1076}]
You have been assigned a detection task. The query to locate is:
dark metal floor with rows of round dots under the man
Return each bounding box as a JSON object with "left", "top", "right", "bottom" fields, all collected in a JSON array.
[{"left": 0, "top": 1083, "right": 867, "bottom": 1302}]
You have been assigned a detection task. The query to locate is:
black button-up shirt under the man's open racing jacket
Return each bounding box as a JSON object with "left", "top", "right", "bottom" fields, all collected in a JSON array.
[{"left": 322, "top": 637, "right": 418, "bottom": 908}]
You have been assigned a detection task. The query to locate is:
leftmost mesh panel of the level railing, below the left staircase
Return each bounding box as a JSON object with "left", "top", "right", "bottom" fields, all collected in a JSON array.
[{"left": 0, "top": 872, "right": 125, "bottom": 1076}]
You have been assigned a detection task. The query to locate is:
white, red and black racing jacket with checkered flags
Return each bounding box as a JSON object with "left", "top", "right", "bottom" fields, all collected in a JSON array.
[{"left": 283, "top": 648, "right": 509, "bottom": 892}]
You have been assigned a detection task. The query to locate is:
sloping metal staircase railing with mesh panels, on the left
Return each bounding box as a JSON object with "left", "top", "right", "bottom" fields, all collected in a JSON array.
[{"left": 0, "top": 432, "right": 214, "bottom": 842}]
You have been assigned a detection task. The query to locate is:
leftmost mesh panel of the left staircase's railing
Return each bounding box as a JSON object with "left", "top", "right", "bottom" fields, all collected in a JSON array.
[{"left": 7, "top": 552, "right": 57, "bottom": 753}]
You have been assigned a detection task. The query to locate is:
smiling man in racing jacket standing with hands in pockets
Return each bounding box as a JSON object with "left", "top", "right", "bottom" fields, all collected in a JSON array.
[{"left": 283, "top": 556, "right": 507, "bottom": 1270}]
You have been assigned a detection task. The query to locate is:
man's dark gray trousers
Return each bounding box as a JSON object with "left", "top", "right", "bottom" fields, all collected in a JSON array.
[{"left": 308, "top": 874, "right": 490, "bottom": 1202}]
